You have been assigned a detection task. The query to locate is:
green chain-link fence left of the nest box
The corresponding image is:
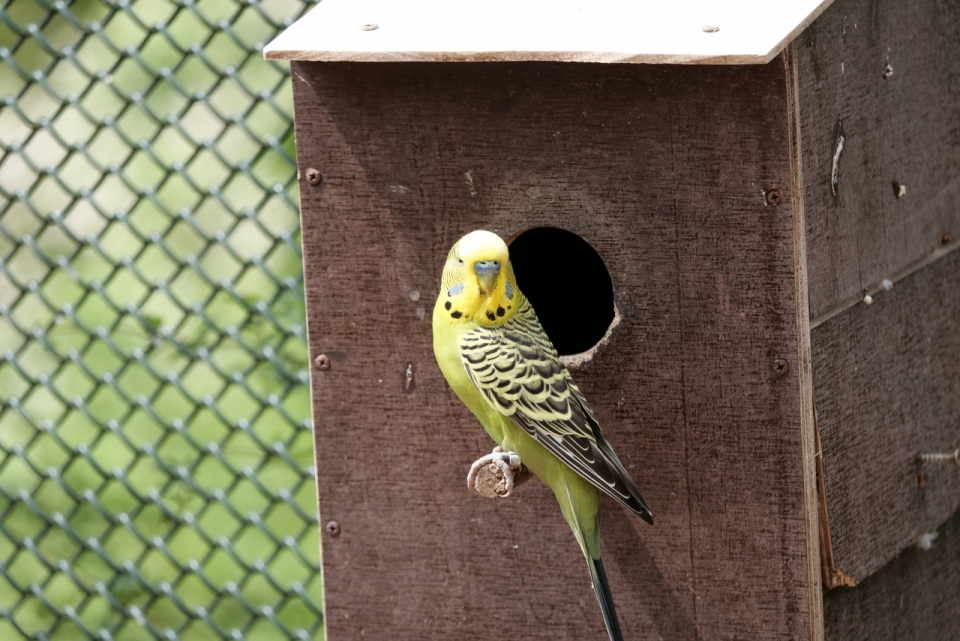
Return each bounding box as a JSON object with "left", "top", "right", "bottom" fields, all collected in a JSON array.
[{"left": 0, "top": 0, "right": 323, "bottom": 641}]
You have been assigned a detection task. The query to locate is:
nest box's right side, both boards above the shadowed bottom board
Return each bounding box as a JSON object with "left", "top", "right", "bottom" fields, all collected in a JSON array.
[{"left": 796, "top": 0, "right": 960, "bottom": 581}]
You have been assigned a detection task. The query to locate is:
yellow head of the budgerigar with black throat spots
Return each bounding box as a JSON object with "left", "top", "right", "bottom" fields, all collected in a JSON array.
[{"left": 434, "top": 230, "right": 522, "bottom": 326}]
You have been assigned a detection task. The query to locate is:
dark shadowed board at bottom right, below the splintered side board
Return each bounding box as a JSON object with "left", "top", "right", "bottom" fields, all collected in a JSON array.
[{"left": 824, "top": 504, "right": 960, "bottom": 641}]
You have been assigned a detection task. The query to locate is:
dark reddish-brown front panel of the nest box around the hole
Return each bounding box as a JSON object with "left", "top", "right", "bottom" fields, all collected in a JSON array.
[{"left": 293, "top": 57, "right": 813, "bottom": 641}]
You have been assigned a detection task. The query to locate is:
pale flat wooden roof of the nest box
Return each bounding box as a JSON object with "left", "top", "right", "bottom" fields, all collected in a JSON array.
[{"left": 264, "top": 0, "right": 832, "bottom": 64}]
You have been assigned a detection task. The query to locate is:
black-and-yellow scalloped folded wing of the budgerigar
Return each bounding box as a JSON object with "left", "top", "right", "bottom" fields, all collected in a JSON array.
[{"left": 459, "top": 301, "right": 652, "bottom": 522}]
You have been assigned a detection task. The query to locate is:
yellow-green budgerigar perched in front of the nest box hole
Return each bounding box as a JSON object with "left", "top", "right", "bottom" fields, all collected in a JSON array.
[{"left": 433, "top": 230, "right": 653, "bottom": 641}]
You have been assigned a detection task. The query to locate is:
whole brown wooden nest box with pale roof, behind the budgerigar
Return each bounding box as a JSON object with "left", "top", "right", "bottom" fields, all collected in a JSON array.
[{"left": 265, "top": 0, "right": 960, "bottom": 641}]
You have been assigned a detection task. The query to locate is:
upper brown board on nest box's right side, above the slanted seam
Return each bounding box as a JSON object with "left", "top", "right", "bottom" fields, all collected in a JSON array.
[{"left": 798, "top": 0, "right": 960, "bottom": 319}]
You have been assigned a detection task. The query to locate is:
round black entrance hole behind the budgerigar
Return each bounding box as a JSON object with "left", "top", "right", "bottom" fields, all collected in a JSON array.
[{"left": 510, "top": 227, "right": 615, "bottom": 356}]
